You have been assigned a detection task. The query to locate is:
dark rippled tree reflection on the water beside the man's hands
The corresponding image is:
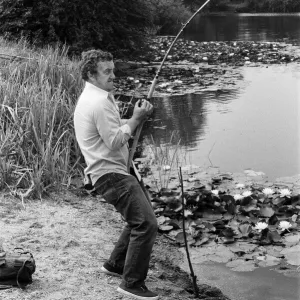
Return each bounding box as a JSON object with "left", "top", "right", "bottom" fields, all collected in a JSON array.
[{"left": 145, "top": 90, "right": 239, "bottom": 149}]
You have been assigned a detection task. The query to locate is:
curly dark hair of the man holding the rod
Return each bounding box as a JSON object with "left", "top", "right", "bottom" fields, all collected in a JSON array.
[{"left": 80, "top": 50, "right": 113, "bottom": 81}]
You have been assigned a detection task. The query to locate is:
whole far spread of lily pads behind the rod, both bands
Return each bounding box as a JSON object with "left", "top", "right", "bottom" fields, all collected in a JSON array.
[{"left": 115, "top": 37, "right": 300, "bottom": 97}]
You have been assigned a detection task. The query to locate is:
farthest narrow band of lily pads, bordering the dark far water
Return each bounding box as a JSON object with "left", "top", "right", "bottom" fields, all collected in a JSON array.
[{"left": 145, "top": 37, "right": 299, "bottom": 65}]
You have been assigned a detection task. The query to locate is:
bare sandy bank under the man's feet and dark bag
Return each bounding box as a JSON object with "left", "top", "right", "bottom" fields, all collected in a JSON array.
[{"left": 0, "top": 189, "right": 229, "bottom": 300}]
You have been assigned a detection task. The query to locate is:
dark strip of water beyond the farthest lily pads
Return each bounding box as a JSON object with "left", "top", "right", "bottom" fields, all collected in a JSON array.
[{"left": 183, "top": 13, "right": 300, "bottom": 45}]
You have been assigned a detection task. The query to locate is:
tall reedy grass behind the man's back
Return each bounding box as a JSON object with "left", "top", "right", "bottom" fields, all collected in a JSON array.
[{"left": 0, "top": 39, "right": 82, "bottom": 197}]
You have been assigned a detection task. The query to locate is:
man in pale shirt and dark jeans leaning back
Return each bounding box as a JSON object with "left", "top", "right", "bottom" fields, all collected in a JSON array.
[{"left": 74, "top": 50, "right": 158, "bottom": 299}]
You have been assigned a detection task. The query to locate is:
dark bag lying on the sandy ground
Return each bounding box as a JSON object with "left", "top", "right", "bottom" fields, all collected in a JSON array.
[{"left": 0, "top": 249, "right": 35, "bottom": 289}]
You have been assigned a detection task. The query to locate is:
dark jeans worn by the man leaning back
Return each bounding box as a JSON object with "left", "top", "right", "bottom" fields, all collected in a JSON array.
[{"left": 95, "top": 173, "right": 157, "bottom": 287}]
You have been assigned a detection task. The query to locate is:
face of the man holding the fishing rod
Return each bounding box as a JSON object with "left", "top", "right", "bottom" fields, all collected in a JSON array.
[{"left": 90, "top": 60, "right": 115, "bottom": 92}]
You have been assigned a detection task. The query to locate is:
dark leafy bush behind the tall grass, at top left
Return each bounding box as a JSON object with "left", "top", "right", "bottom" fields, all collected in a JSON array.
[{"left": 0, "top": 0, "right": 150, "bottom": 53}]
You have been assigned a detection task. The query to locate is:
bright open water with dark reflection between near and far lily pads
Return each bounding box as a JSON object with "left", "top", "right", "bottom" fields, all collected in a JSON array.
[{"left": 144, "top": 65, "right": 300, "bottom": 180}]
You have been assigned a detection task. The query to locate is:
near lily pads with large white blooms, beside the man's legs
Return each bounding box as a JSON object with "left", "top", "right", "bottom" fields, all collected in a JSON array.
[{"left": 145, "top": 166, "right": 300, "bottom": 271}]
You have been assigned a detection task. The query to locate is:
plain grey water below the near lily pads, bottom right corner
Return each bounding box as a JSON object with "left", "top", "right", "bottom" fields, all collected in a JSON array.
[{"left": 181, "top": 262, "right": 300, "bottom": 300}]
